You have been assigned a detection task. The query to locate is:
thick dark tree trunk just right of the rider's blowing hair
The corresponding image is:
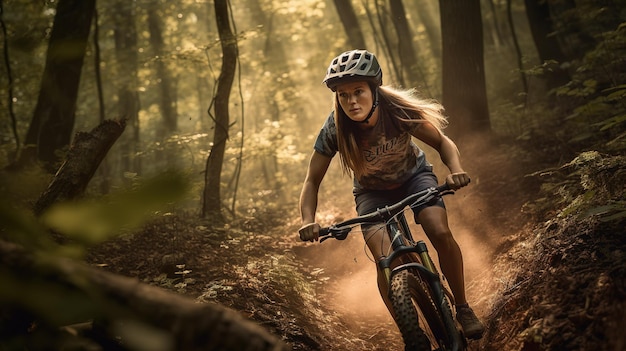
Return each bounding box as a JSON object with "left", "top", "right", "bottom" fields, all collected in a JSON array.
[{"left": 439, "top": 0, "right": 490, "bottom": 139}]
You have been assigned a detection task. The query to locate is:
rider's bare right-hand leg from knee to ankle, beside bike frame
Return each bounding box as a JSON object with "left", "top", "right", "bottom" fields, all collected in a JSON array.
[{"left": 418, "top": 206, "right": 467, "bottom": 304}]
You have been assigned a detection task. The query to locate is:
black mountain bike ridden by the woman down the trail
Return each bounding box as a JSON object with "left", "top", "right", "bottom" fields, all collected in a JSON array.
[{"left": 320, "top": 184, "right": 467, "bottom": 351}]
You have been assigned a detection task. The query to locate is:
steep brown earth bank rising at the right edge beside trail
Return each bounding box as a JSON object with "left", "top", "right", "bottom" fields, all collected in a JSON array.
[{"left": 472, "top": 153, "right": 626, "bottom": 350}]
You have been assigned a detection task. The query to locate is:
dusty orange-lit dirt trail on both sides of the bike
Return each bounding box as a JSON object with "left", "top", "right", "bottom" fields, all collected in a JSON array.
[{"left": 294, "top": 190, "right": 502, "bottom": 350}]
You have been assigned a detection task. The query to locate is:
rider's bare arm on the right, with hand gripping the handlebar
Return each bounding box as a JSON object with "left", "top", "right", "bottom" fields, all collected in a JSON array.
[{"left": 413, "top": 123, "right": 470, "bottom": 189}]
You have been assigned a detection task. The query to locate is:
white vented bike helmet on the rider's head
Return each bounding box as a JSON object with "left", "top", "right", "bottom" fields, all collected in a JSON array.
[{"left": 323, "top": 50, "right": 383, "bottom": 91}]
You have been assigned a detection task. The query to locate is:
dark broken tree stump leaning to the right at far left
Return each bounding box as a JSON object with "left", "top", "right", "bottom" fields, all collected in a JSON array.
[{"left": 33, "top": 120, "right": 126, "bottom": 216}]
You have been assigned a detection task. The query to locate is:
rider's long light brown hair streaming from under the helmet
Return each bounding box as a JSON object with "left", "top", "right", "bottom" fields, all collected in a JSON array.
[{"left": 334, "top": 85, "right": 448, "bottom": 177}]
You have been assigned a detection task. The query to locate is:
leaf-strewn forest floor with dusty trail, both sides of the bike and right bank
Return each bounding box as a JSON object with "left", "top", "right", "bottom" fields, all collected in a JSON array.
[{"left": 89, "top": 140, "right": 626, "bottom": 351}]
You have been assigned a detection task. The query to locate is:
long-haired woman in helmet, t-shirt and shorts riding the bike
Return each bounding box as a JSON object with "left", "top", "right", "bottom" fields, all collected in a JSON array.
[{"left": 299, "top": 50, "right": 485, "bottom": 339}]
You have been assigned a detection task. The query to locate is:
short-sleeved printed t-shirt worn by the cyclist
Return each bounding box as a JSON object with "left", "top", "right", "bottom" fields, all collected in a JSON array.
[{"left": 314, "top": 109, "right": 426, "bottom": 190}]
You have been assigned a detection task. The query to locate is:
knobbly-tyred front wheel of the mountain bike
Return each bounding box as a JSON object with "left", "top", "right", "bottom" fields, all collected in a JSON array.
[{"left": 389, "top": 270, "right": 452, "bottom": 351}]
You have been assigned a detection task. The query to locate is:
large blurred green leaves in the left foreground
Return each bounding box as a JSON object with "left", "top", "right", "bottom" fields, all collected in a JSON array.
[{"left": 0, "top": 172, "right": 188, "bottom": 345}]
